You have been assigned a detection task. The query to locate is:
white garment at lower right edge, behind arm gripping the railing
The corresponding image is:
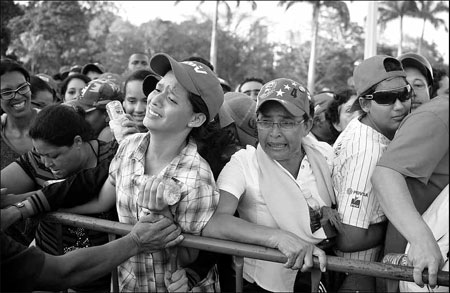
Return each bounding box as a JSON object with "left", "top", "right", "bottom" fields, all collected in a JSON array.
[{"left": 400, "top": 185, "right": 449, "bottom": 292}]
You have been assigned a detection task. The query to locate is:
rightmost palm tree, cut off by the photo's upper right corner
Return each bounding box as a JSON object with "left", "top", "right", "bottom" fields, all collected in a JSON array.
[{"left": 415, "top": 1, "right": 449, "bottom": 54}]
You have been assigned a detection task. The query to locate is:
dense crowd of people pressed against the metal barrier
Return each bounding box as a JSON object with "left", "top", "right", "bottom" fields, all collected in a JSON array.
[{"left": 0, "top": 52, "right": 449, "bottom": 292}]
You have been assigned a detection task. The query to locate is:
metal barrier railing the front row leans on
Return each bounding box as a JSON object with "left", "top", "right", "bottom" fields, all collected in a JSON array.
[{"left": 44, "top": 212, "right": 449, "bottom": 292}]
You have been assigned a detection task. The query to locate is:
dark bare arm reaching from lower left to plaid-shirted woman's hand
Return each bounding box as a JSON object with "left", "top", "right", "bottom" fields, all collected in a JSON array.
[{"left": 34, "top": 215, "right": 183, "bottom": 290}]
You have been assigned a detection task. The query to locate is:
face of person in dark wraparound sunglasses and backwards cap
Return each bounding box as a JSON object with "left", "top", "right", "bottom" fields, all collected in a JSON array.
[{"left": 363, "top": 78, "right": 411, "bottom": 139}]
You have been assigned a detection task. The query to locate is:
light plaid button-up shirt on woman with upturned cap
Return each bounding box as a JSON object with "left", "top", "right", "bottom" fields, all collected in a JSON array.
[{"left": 109, "top": 133, "right": 219, "bottom": 292}]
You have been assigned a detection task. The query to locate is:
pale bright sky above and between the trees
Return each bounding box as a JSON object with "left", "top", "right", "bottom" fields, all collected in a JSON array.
[{"left": 114, "top": 1, "right": 449, "bottom": 64}]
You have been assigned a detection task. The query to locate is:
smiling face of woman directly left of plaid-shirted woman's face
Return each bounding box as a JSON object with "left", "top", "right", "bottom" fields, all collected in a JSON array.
[{"left": 123, "top": 80, "right": 147, "bottom": 130}]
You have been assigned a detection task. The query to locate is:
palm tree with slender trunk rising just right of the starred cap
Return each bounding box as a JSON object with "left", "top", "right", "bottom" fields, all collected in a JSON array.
[{"left": 278, "top": 1, "right": 350, "bottom": 94}]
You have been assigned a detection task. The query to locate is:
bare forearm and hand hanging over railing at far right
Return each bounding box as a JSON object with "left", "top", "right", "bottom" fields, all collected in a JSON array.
[{"left": 372, "top": 166, "right": 444, "bottom": 288}]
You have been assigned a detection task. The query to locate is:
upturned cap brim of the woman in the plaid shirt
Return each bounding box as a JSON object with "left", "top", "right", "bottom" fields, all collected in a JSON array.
[{"left": 150, "top": 53, "right": 201, "bottom": 96}]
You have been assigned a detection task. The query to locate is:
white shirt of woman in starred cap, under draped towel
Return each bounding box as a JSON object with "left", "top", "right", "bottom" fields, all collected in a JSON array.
[{"left": 217, "top": 142, "right": 332, "bottom": 292}]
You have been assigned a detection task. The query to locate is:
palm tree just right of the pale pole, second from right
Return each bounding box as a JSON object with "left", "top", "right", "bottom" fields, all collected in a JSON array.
[{"left": 378, "top": 1, "right": 417, "bottom": 56}]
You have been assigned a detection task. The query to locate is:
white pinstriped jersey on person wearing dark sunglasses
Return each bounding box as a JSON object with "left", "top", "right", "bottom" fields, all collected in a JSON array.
[{"left": 332, "top": 118, "right": 390, "bottom": 261}]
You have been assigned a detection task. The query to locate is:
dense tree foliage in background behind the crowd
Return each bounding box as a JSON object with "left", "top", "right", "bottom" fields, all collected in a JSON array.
[{"left": 1, "top": 1, "right": 443, "bottom": 92}]
